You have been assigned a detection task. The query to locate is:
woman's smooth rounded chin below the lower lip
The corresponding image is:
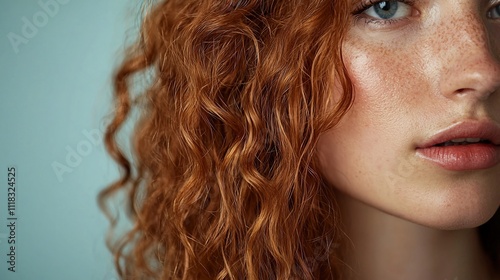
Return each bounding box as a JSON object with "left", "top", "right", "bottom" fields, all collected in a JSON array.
[{"left": 399, "top": 172, "right": 500, "bottom": 230}]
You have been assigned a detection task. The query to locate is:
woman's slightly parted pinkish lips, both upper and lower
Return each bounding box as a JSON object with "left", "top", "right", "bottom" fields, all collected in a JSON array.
[{"left": 416, "top": 121, "right": 500, "bottom": 171}]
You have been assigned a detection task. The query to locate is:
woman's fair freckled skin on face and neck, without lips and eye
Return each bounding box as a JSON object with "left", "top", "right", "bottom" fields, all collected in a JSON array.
[{"left": 318, "top": 0, "right": 500, "bottom": 280}]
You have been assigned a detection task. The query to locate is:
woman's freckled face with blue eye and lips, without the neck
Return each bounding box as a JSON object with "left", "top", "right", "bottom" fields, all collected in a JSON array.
[{"left": 318, "top": 0, "right": 500, "bottom": 229}]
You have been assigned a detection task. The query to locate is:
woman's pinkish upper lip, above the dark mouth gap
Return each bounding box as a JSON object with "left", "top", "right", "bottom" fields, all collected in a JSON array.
[{"left": 418, "top": 121, "right": 500, "bottom": 148}]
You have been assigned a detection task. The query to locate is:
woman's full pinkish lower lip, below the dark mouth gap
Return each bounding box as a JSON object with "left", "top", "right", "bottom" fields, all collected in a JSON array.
[{"left": 417, "top": 143, "right": 500, "bottom": 171}]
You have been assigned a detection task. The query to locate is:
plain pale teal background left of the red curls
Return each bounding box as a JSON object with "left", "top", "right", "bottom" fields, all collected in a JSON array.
[{"left": 0, "top": 0, "right": 141, "bottom": 280}]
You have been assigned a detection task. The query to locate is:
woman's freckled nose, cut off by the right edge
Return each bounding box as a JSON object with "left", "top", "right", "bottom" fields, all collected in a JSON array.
[{"left": 437, "top": 9, "right": 500, "bottom": 100}]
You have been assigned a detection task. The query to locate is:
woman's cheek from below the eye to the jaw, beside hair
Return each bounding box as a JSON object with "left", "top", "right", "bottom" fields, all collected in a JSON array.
[{"left": 318, "top": 41, "right": 425, "bottom": 200}]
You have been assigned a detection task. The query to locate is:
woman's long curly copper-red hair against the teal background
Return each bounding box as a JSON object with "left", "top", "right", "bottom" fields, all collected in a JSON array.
[{"left": 99, "top": 0, "right": 360, "bottom": 279}]
